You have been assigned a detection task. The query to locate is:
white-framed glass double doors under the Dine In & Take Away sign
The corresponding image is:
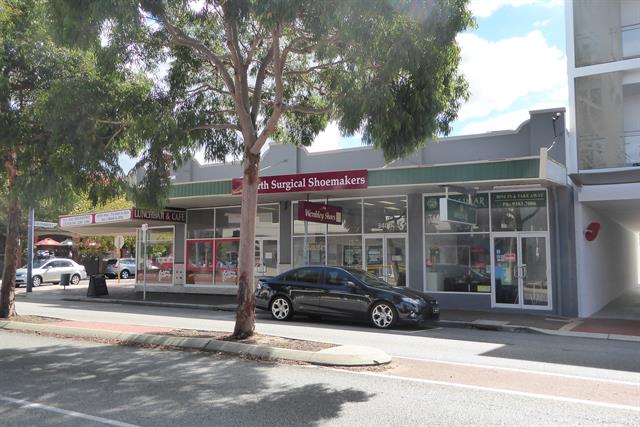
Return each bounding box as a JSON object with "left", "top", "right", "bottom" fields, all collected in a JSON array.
[{"left": 492, "top": 233, "right": 551, "bottom": 308}]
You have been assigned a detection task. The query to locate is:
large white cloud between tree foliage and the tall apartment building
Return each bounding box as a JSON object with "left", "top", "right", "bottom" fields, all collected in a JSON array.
[{"left": 458, "top": 30, "right": 567, "bottom": 120}]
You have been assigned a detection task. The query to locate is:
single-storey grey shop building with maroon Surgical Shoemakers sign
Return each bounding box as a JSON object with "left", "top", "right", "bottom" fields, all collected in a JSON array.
[{"left": 61, "top": 109, "right": 577, "bottom": 315}]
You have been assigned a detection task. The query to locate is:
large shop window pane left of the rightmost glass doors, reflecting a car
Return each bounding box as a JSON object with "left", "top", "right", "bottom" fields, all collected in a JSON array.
[{"left": 425, "top": 234, "right": 491, "bottom": 293}]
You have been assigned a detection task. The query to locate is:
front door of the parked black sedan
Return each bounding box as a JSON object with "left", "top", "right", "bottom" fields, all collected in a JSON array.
[{"left": 318, "top": 267, "right": 371, "bottom": 320}]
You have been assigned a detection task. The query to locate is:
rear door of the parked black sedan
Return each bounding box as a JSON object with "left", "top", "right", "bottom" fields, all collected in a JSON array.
[{"left": 283, "top": 267, "right": 323, "bottom": 313}]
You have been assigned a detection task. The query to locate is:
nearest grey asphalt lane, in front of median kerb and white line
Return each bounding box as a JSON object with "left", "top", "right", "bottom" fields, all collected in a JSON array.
[{"left": 0, "top": 331, "right": 640, "bottom": 427}]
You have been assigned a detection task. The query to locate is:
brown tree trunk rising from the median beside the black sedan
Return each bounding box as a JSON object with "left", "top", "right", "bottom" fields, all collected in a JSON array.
[{"left": 233, "top": 147, "right": 260, "bottom": 340}]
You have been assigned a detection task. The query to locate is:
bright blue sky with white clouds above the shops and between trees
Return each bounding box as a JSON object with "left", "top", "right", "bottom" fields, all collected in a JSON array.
[{"left": 121, "top": 0, "right": 568, "bottom": 169}]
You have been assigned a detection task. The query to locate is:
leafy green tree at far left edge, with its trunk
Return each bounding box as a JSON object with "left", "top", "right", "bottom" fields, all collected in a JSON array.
[{"left": 0, "top": 0, "right": 151, "bottom": 317}]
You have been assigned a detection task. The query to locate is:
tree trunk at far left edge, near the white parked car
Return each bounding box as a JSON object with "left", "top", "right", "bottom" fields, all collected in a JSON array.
[{"left": 0, "top": 151, "right": 22, "bottom": 319}]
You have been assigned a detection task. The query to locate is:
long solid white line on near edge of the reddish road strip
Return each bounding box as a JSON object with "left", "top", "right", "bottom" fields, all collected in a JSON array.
[{"left": 324, "top": 368, "right": 640, "bottom": 412}]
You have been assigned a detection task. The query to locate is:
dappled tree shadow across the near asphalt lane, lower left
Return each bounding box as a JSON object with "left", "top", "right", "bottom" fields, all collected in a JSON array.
[{"left": 0, "top": 334, "right": 373, "bottom": 425}]
